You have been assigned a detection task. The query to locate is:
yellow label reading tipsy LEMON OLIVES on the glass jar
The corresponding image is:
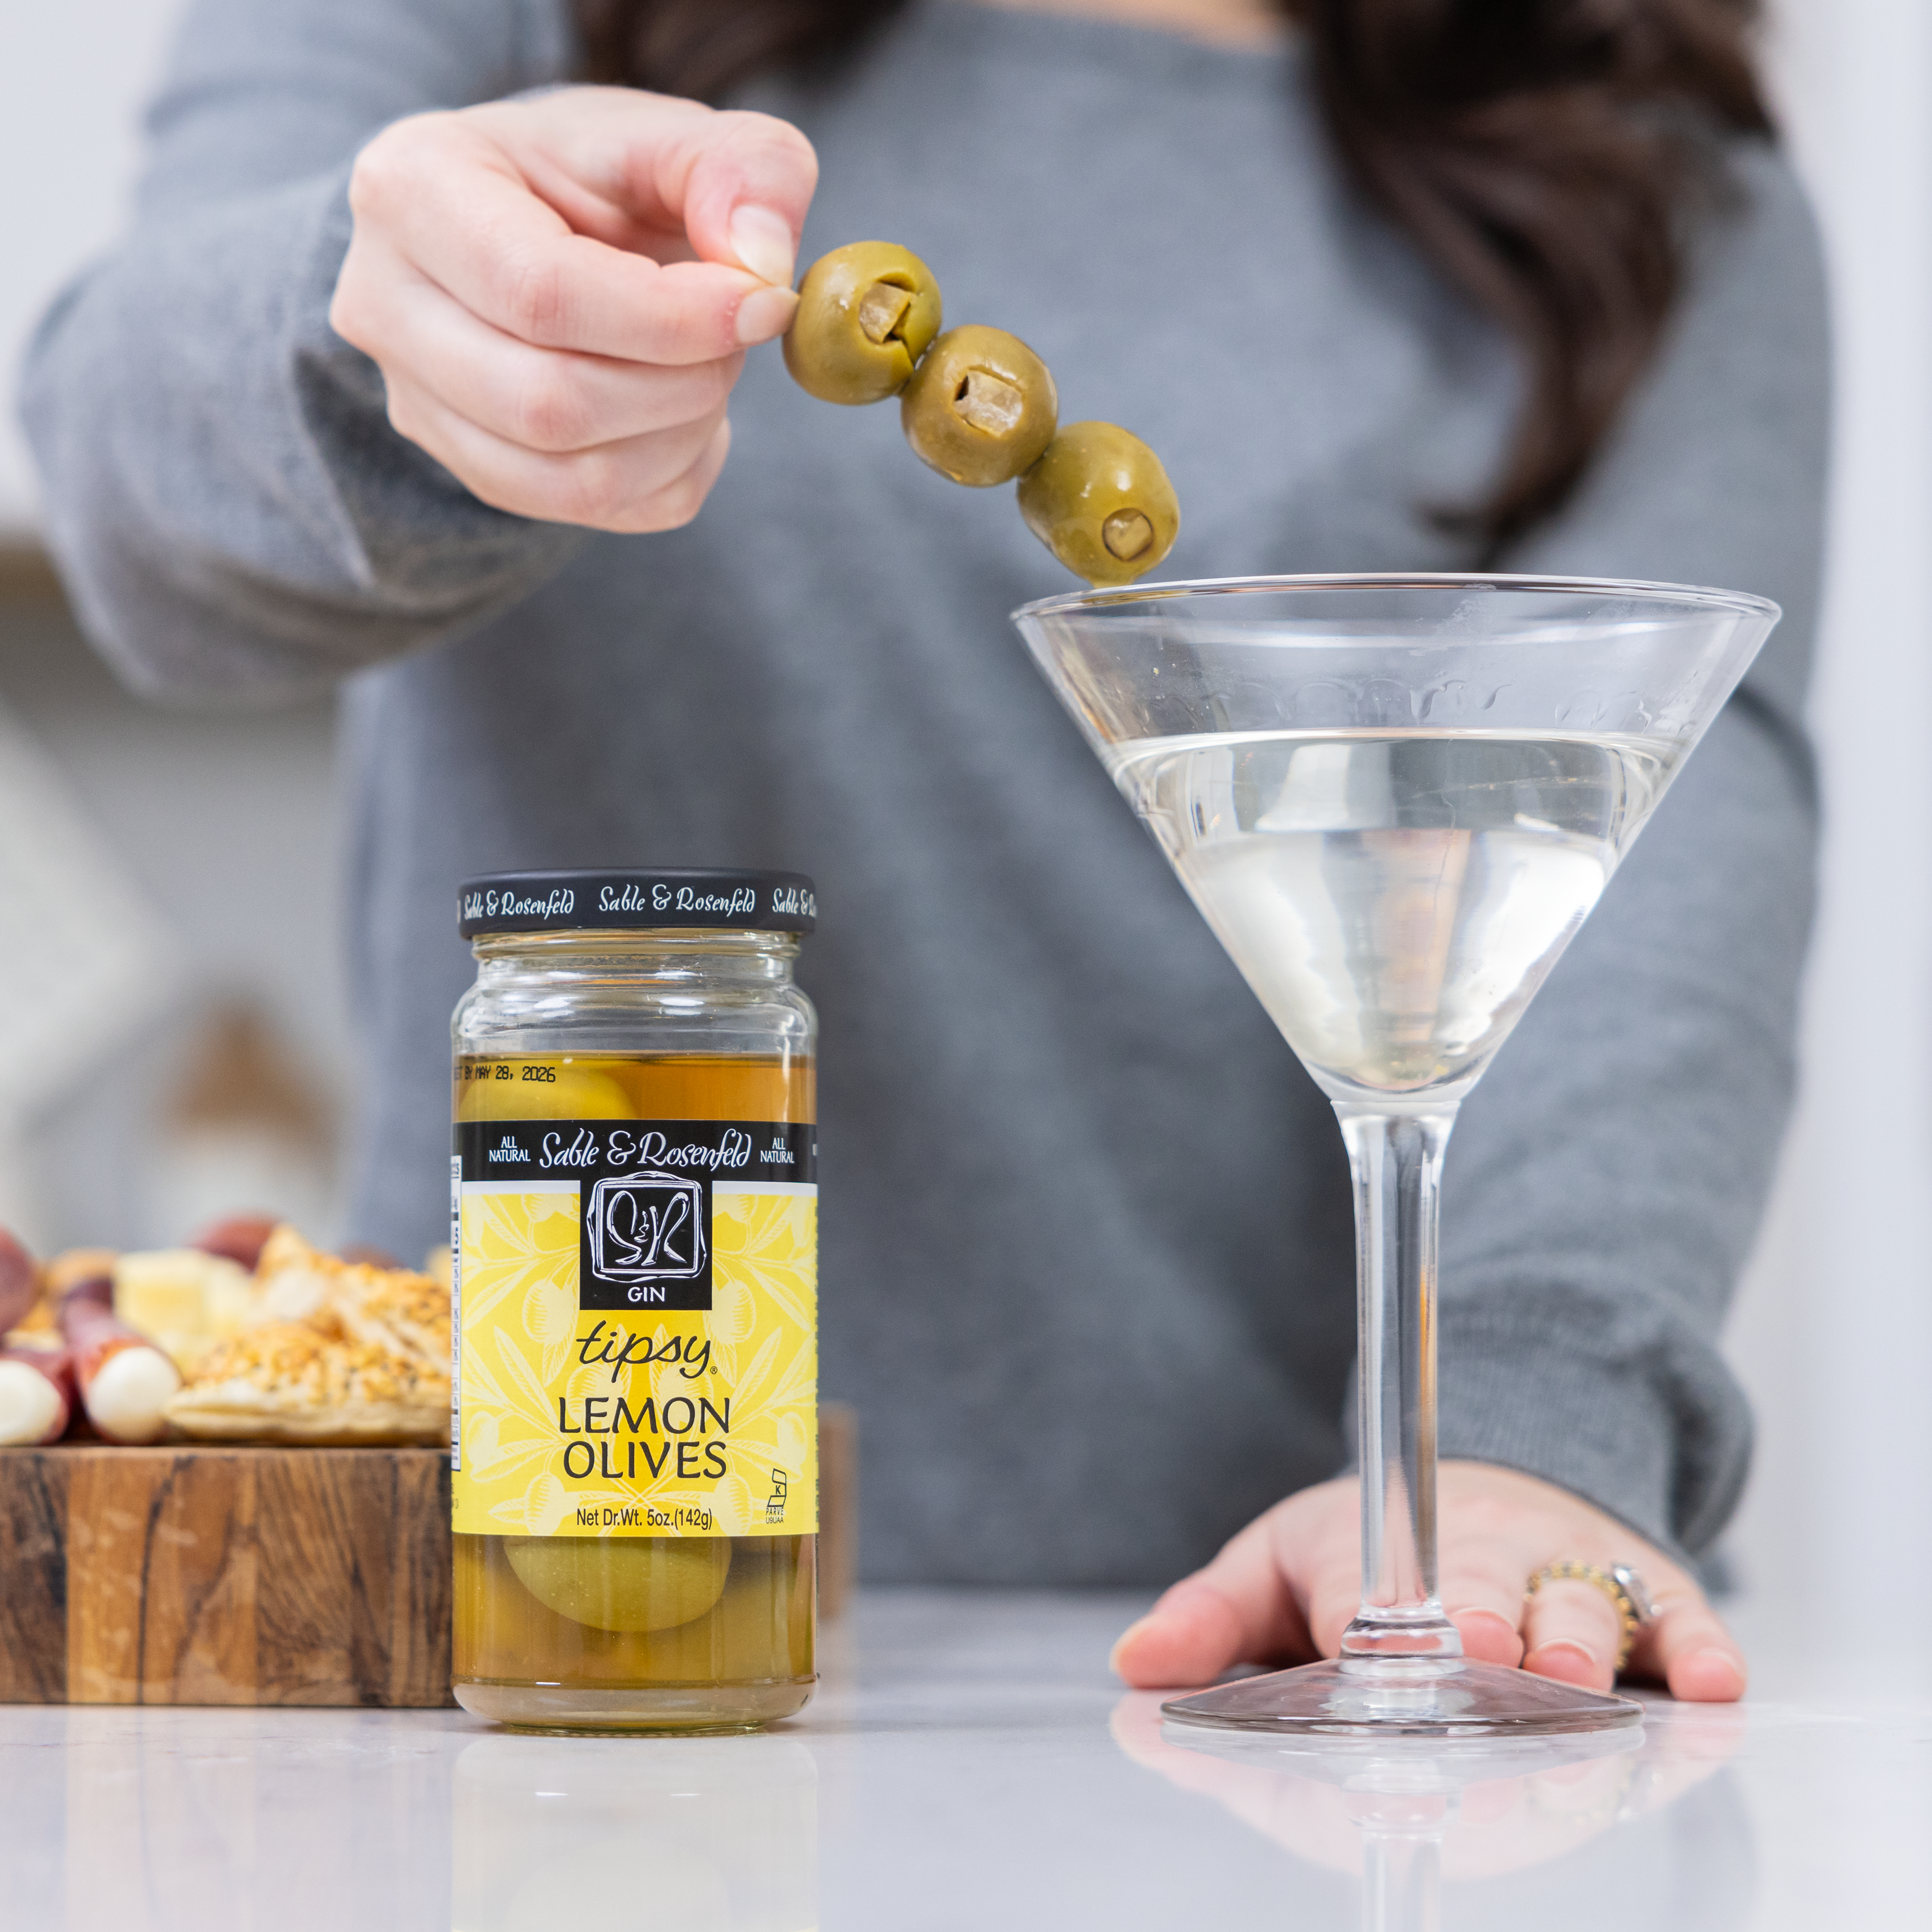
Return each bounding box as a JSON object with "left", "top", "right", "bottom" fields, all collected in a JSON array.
[{"left": 452, "top": 1175, "right": 819, "bottom": 1536}]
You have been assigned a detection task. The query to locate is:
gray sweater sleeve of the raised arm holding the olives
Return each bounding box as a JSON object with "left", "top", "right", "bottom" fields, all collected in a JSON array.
[{"left": 21, "top": 0, "right": 583, "bottom": 705}]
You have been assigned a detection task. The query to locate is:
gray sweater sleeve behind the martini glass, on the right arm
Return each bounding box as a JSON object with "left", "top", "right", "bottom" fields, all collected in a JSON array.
[{"left": 1439, "top": 145, "right": 1830, "bottom": 1551}]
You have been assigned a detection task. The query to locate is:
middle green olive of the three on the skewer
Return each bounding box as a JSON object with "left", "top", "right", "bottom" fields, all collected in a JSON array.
[{"left": 898, "top": 327, "right": 1061, "bottom": 489}]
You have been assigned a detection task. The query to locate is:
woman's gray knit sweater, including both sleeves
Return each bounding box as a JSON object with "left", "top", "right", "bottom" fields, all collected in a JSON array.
[{"left": 25, "top": 0, "right": 1826, "bottom": 1584}]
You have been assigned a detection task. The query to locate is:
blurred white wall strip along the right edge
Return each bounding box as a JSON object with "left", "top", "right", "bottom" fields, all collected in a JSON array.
[{"left": 1733, "top": 0, "right": 1932, "bottom": 1642}]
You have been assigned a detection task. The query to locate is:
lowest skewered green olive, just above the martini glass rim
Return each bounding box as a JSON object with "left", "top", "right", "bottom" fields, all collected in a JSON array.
[{"left": 1020, "top": 423, "right": 1180, "bottom": 583}]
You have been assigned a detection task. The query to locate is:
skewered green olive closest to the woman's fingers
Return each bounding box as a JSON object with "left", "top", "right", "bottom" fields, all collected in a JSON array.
[{"left": 784, "top": 242, "right": 939, "bottom": 404}]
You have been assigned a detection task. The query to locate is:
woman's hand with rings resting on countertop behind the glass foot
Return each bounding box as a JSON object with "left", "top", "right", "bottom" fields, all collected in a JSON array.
[{"left": 1113, "top": 1463, "right": 1745, "bottom": 1704}]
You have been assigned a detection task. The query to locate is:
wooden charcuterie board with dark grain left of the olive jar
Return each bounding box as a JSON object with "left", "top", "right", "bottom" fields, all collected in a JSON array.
[{"left": 0, "top": 1443, "right": 450, "bottom": 1706}]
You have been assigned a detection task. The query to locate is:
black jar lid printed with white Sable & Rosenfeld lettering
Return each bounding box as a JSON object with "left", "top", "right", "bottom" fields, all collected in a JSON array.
[{"left": 458, "top": 866, "right": 819, "bottom": 939}]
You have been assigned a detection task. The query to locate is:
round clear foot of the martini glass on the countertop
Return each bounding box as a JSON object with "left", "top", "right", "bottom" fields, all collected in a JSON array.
[{"left": 1161, "top": 1658, "right": 1644, "bottom": 1737}]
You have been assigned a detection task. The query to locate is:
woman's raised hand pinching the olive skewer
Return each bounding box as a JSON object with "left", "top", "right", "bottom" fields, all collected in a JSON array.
[{"left": 328, "top": 87, "right": 817, "bottom": 531}]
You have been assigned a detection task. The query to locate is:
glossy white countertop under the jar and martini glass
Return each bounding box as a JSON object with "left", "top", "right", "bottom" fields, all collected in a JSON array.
[{"left": 0, "top": 1592, "right": 1932, "bottom": 1932}]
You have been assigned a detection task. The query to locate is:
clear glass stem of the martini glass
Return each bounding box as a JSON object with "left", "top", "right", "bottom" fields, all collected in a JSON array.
[{"left": 1335, "top": 1101, "right": 1463, "bottom": 1675}]
